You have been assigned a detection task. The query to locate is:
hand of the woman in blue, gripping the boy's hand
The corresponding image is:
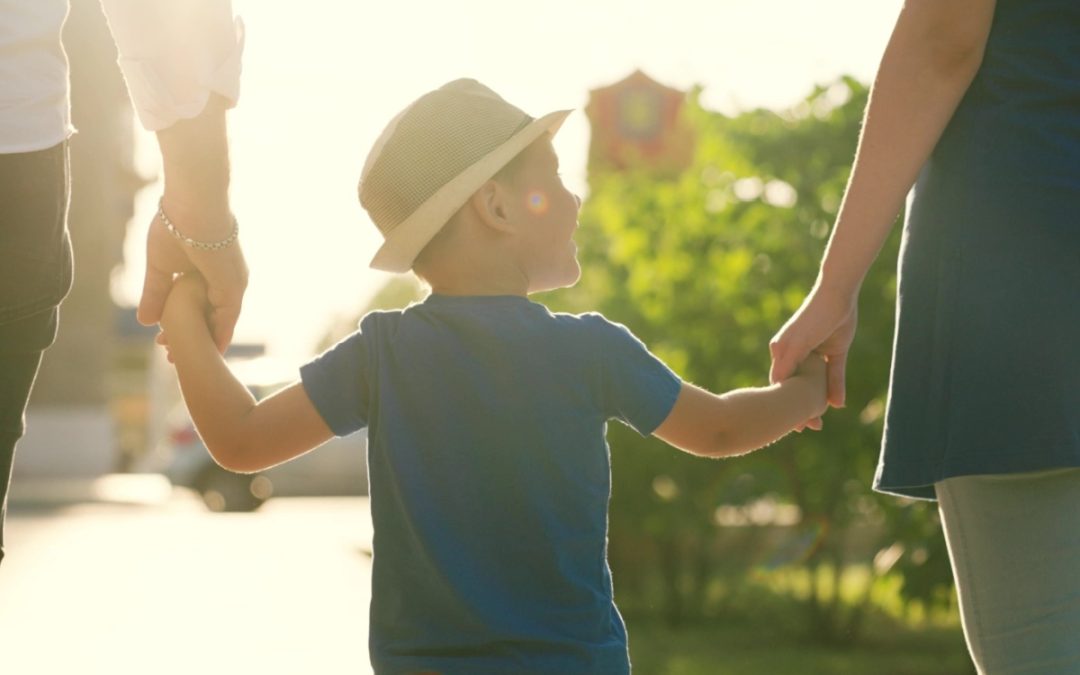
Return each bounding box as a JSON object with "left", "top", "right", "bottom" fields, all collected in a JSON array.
[{"left": 769, "top": 285, "right": 859, "bottom": 431}]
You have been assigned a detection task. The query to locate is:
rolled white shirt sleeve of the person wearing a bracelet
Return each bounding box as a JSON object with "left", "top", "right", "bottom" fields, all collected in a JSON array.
[{"left": 100, "top": 0, "right": 244, "bottom": 131}]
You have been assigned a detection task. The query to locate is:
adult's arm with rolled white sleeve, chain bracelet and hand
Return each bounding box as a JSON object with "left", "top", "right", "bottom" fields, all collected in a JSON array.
[{"left": 100, "top": 0, "right": 247, "bottom": 352}]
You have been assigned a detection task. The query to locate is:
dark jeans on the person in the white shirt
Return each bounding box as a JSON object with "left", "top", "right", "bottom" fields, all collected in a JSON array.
[{"left": 0, "top": 143, "right": 71, "bottom": 561}]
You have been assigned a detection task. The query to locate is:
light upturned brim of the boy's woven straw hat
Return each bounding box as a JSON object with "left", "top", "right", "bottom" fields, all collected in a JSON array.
[{"left": 370, "top": 110, "right": 572, "bottom": 272}]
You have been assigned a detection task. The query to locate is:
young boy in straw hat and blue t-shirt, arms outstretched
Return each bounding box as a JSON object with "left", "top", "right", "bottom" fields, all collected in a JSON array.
[{"left": 156, "top": 80, "right": 825, "bottom": 675}]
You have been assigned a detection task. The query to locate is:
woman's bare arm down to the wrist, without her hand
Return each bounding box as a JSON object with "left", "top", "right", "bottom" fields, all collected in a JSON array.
[{"left": 821, "top": 0, "right": 995, "bottom": 295}]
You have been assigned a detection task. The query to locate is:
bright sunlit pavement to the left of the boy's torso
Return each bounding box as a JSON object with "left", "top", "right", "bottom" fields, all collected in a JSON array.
[{"left": 0, "top": 480, "right": 372, "bottom": 675}]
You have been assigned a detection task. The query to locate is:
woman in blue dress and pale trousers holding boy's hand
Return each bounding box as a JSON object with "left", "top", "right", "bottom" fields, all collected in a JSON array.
[{"left": 770, "top": 0, "right": 1080, "bottom": 674}]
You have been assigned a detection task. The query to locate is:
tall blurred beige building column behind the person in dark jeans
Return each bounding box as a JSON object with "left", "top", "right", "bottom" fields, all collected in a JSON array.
[{"left": 15, "top": 0, "right": 153, "bottom": 476}]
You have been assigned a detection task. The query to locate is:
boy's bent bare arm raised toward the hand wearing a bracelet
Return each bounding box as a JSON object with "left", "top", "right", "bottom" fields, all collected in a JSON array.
[{"left": 161, "top": 274, "right": 334, "bottom": 473}]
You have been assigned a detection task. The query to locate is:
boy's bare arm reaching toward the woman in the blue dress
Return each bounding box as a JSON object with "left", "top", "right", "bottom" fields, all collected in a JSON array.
[{"left": 652, "top": 354, "right": 827, "bottom": 457}]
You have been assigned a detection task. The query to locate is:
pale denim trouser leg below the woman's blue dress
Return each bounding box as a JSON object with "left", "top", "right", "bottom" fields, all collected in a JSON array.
[{"left": 935, "top": 469, "right": 1080, "bottom": 675}]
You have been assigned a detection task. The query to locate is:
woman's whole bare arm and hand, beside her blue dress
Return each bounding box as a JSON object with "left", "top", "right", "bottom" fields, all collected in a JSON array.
[{"left": 770, "top": 0, "right": 995, "bottom": 406}]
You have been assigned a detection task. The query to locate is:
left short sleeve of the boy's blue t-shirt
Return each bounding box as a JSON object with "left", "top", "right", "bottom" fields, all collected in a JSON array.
[{"left": 300, "top": 329, "right": 370, "bottom": 436}]
